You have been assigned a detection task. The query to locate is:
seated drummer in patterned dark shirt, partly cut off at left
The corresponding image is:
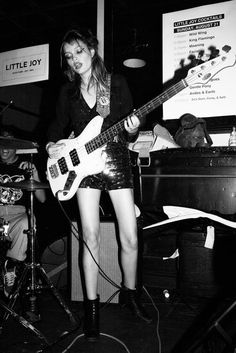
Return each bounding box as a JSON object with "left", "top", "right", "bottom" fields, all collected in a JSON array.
[{"left": 0, "top": 127, "right": 46, "bottom": 297}]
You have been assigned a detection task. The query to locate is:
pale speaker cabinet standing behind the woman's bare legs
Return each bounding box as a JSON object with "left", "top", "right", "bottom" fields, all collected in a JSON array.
[{"left": 71, "top": 222, "right": 121, "bottom": 303}]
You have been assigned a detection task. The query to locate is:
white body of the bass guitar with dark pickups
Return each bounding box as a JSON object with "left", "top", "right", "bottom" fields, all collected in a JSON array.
[{"left": 47, "top": 115, "right": 105, "bottom": 201}]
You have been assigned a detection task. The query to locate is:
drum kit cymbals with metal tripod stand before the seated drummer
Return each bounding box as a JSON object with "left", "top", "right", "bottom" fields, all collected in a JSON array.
[{"left": 0, "top": 137, "right": 77, "bottom": 346}]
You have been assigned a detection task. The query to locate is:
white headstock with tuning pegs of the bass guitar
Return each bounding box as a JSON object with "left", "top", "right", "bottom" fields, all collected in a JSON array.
[{"left": 185, "top": 45, "right": 236, "bottom": 86}]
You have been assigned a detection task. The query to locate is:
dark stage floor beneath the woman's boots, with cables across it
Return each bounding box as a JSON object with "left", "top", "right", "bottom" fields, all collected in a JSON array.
[{"left": 0, "top": 288, "right": 236, "bottom": 353}]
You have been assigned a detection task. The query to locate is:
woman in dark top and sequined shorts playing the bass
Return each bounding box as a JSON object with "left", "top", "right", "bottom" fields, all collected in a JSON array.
[{"left": 46, "top": 28, "right": 151, "bottom": 341}]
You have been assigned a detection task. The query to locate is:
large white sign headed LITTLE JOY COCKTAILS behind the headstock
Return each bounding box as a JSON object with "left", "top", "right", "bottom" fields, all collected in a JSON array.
[{"left": 162, "top": 0, "right": 236, "bottom": 120}]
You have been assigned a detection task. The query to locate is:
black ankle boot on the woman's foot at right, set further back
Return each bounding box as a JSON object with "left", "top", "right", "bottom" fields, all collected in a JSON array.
[{"left": 119, "top": 287, "right": 152, "bottom": 323}]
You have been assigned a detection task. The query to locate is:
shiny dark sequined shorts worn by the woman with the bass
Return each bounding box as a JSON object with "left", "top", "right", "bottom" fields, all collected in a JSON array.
[{"left": 79, "top": 142, "right": 133, "bottom": 191}]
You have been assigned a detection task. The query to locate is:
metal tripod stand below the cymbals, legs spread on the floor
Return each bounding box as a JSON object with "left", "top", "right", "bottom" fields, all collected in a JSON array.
[{"left": 0, "top": 166, "right": 78, "bottom": 346}]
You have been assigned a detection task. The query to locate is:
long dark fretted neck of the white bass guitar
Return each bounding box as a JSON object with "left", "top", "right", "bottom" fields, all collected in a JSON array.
[{"left": 85, "top": 79, "right": 188, "bottom": 153}]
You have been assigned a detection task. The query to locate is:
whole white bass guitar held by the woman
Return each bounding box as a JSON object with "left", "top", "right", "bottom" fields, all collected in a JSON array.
[{"left": 47, "top": 47, "right": 236, "bottom": 201}]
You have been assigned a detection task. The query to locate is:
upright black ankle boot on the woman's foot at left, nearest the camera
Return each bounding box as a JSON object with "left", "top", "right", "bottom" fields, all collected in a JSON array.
[{"left": 84, "top": 297, "right": 99, "bottom": 341}]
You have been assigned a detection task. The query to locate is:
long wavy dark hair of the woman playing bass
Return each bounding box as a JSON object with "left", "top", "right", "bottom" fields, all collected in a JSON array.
[{"left": 60, "top": 28, "right": 108, "bottom": 91}]
